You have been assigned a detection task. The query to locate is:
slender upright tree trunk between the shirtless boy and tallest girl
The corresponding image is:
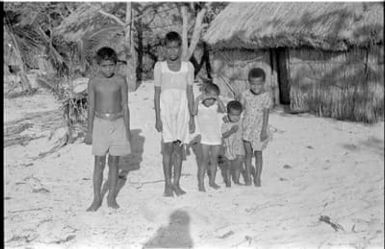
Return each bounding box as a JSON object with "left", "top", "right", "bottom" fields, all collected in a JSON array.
[{"left": 124, "top": 2, "right": 136, "bottom": 92}]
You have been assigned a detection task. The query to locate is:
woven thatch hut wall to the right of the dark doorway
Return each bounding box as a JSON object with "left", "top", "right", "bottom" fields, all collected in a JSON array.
[{"left": 288, "top": 46, "right": 384, "bottom": 123}]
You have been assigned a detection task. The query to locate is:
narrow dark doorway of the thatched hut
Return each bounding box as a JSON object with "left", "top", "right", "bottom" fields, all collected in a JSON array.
[{"left": 275, "top": 48, "right": 290, "bottom": 105}]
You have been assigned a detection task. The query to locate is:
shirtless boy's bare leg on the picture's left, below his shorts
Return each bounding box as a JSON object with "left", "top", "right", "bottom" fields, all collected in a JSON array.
[{"left": 87, "top": 156, "right": 106, "bottom": 211}]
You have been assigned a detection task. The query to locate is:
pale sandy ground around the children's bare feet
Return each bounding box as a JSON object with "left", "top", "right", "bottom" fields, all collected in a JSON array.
[{"left": 4, "top": 83, "right": 384, "bottom": 249}]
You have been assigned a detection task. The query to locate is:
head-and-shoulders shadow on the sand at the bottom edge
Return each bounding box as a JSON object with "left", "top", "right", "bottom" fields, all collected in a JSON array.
[{"left": 143, "top": 209, "right": 193, "bottom": 248}]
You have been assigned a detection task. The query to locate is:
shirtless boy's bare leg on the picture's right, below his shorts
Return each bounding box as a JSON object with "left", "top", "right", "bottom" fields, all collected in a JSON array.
[{"left": 107, "top": 155, "right": 119, "bottom": 209}]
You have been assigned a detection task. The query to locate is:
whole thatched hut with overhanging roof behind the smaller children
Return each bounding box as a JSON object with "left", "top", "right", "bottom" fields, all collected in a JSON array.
[{"left": 204, "top": 2, "right": 384, "bottom": 122}]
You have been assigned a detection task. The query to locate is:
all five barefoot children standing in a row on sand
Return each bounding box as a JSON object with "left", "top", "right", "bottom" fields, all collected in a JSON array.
[{"left": 85, "top": 32, "right": 272, "bottom": 211}]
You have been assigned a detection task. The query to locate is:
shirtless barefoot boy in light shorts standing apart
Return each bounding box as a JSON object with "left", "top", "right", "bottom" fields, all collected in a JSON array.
[{"left": 85, "top": 47, "right": 131, "bottom": 211}]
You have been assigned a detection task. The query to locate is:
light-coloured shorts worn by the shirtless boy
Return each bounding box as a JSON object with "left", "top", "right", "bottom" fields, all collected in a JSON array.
[{"left": 92, "top": 117, "right": 131, "bottom": 156}]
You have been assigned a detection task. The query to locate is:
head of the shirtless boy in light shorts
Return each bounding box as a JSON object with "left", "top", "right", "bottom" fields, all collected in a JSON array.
[{"left": 96, "top": 47, "right": 118, "bottom": 78}]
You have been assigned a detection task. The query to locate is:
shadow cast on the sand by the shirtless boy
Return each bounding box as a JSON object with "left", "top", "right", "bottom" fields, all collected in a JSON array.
[{"left": 102, "top": 129, "right": 145, "bottom": 197}]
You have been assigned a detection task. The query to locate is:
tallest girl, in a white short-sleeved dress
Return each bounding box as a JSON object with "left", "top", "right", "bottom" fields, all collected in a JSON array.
[{"left": 154, "top": 32, "right": 194, "bottom": 196}]
